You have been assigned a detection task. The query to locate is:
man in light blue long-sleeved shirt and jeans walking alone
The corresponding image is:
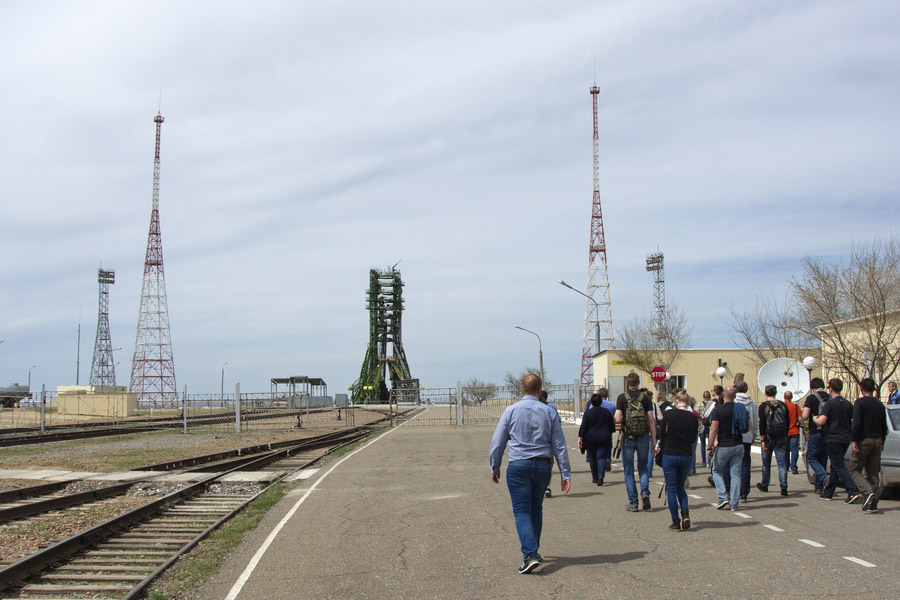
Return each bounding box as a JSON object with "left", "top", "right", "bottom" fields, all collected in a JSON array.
[{"left": 490, "top": 375, "right": 571, "bottom": 574}]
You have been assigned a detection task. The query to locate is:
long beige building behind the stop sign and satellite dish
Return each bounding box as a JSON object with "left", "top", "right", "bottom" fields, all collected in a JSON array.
[{"left": 594, "top": 348, "right": 821, "bottom": 401}]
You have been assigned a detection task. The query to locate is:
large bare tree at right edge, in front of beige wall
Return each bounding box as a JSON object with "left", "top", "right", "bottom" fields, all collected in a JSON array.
[{"left": 791, "top": 238, "right": 900, "bottom": 391}]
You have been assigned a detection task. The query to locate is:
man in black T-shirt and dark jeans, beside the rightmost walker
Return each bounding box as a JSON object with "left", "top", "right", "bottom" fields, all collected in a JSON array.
[{"left": 813, "top": 378, "right": 862, "bottom": 504}]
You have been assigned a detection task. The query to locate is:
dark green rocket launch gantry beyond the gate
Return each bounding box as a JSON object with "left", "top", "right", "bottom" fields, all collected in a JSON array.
[{"left": 350, "top": 265, "right": 419, "bottom": 404}]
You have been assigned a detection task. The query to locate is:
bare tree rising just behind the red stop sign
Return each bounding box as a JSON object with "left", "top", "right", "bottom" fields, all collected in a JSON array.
[{"left": 618, "top": 303, "right": 692, "bottom": 375}]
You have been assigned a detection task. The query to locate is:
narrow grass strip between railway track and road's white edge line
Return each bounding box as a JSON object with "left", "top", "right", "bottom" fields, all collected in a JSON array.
[{"left": 149, "top": 483, "right": 285, "bottom": 600}]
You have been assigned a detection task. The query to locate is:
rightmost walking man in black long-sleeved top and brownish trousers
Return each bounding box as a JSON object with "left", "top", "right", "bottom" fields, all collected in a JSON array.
[{"left": 850, "top": 377, "right": 887, "bottom": 513}]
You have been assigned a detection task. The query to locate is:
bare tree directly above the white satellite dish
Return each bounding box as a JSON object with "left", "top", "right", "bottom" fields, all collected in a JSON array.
[{"left": 731, "top": 296, "right": 818, "bottom": 363}]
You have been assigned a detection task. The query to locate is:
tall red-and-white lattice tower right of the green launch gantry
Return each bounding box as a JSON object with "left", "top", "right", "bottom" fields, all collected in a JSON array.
[{"left": 581, "top": 85, "right": 616, "bottom": 386}]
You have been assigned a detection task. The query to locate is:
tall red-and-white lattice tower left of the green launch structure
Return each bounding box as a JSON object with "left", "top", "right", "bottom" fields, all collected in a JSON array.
[{"left": 131, "top": 114, "right": 177, "bottom": 406}]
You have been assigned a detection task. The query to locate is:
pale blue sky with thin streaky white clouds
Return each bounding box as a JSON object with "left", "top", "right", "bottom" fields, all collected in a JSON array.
[{"left": 0, "top": 0, "right": 900, "bottom": 394}]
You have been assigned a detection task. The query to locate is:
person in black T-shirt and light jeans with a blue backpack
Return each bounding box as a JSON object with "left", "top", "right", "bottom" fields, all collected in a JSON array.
[{"left": 706, "top": 386, "right": 750, "bottom": 510}]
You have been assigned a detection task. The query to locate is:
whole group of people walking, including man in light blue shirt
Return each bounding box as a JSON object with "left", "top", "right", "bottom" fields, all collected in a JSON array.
[{"left": 490, "top": 373, "right": 896, "bottom": 573}]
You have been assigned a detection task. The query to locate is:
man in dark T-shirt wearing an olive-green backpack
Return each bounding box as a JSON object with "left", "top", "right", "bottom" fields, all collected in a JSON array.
[{"left": 615, "top": 373, "right": 656, "bottom": 512}]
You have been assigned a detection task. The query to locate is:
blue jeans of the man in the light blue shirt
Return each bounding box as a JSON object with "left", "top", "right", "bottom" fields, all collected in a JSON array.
[{"left": 506, "top": 458, "right": 553, "bottom": 556}]
